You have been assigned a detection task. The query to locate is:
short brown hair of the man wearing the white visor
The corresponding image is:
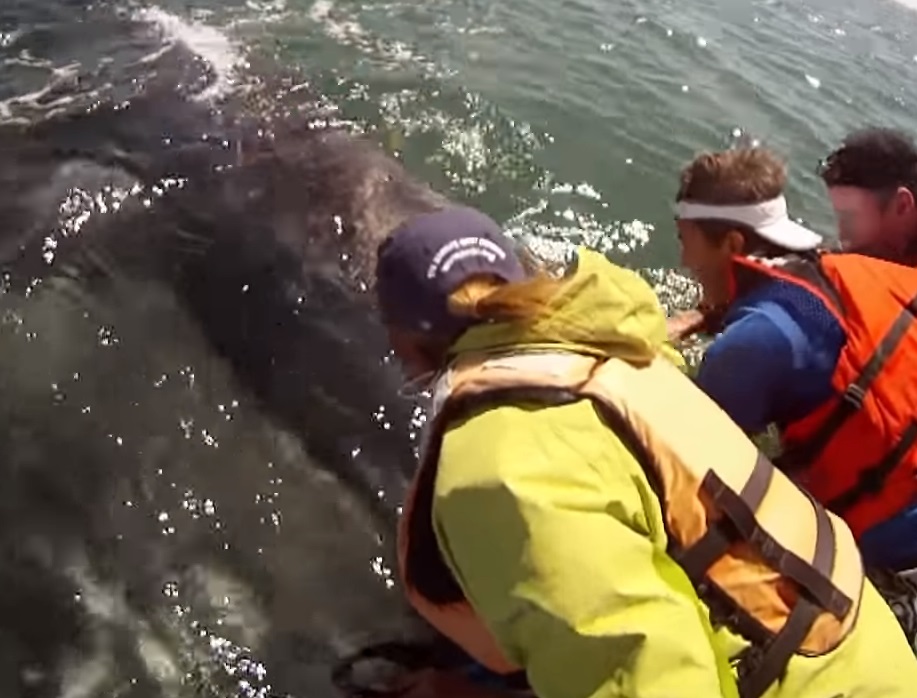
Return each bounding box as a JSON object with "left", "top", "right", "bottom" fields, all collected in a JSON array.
[{"left": 675, "top": 148, "right": 790, "bottom": 257}]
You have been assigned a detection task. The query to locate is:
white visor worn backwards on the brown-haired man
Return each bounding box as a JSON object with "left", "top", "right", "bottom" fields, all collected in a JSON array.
[{"left": 675, "top": 196, "right": 822, "bottom": 252}]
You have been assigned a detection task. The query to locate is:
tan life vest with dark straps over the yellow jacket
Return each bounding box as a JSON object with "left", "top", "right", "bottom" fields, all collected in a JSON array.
[{"left": 399, "top": 352, "right": 864, "bottom": 698}]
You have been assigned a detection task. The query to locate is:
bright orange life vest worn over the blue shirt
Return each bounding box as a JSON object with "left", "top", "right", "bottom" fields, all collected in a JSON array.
[{"left": 733, "top": 253, "right": 917, "bottom": 538}]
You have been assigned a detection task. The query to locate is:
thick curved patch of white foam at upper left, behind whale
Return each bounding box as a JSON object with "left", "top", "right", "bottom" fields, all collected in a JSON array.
[{"left": 133, "top": 6, "right": 247, "bottom": 100}]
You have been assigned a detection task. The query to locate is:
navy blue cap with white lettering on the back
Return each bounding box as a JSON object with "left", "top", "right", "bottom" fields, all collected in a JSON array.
[{"left": 376, "top": 207, "right": 526, "bottom": 336}]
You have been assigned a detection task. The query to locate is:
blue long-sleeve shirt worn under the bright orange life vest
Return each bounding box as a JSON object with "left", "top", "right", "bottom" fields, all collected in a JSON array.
[{"left": 697, "top": 280, "right": 917, "bottom": 569}]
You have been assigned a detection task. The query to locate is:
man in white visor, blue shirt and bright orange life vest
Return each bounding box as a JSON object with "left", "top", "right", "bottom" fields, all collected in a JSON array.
[{"left": 670, "top": 148, "right": 917, "bottom": 612}]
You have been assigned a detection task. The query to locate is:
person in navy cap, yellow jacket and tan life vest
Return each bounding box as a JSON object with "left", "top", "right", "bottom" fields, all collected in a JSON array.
[{"left": 364, "top": 207, "right": 917, "bottom": 698}]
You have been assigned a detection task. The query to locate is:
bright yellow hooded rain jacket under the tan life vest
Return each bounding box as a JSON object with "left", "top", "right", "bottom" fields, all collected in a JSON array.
[{"left": 404, "top": 250, "right": 917, "bottom": 698}]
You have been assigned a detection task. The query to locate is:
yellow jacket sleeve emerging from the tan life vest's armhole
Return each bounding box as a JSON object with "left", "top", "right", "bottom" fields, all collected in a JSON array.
[{"left": 434, "top": 404, "right": 737, "bottom": 698}]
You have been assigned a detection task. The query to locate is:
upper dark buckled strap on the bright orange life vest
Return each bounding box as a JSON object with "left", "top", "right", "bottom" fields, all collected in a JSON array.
[{"left": 779, "top": 296, "right": 917, "bottom": 472}]
